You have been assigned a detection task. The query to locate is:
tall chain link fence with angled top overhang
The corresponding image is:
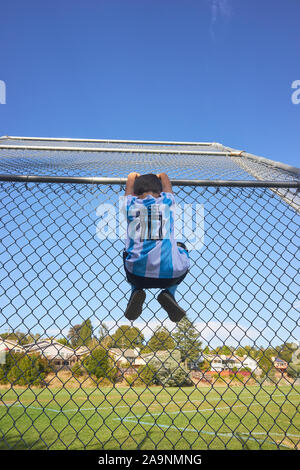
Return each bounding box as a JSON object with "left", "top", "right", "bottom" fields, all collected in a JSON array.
[{"left": 0, "top": 139, "right": 300, "bottom": 450}]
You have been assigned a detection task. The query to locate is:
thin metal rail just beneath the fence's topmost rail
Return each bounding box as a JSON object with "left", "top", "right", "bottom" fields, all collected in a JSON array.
[{"left": 0, "top": 144, "right": 232, "bottom": 157}]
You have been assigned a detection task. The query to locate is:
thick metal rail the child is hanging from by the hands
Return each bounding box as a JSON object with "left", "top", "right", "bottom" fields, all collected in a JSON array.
[{"left": 0, "top": 175, "right": 300, "bottom": 189}]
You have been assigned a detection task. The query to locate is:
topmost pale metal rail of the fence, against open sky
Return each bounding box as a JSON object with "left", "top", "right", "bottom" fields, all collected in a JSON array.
[{"left": 0, "top": 135, "right": 216, "bottom": 146}]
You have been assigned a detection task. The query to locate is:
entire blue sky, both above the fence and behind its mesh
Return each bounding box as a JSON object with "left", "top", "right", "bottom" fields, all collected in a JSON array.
[{"left": 0, "top": 0, "right": 300, "bottom": 344}]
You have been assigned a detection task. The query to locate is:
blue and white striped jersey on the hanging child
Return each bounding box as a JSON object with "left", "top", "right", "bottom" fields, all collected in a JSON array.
[{"left": 125, "top": 192, "right": 190, "bottom": 278}]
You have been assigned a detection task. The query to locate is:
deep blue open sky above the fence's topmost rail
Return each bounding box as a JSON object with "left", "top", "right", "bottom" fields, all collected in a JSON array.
[{"left": 0, "top": 0, "right": 300, "bottom": 166}]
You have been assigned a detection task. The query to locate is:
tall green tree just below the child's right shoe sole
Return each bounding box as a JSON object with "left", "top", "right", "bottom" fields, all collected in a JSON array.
[{"left": 174, "top": 316, "right": 201, "bottom": 368}]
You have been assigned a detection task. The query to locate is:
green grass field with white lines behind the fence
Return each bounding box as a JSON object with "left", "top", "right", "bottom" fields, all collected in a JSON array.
[{"left": 0, "top": 386, "right": 300, "bottom": 450}]
